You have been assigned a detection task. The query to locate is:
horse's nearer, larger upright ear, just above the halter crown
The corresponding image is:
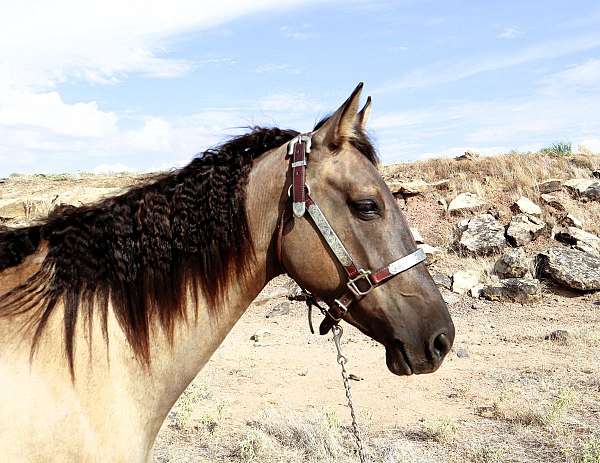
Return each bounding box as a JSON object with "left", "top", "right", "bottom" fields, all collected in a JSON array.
[{"left": 314, "top": 82, "right": 363, "bottom": 146}]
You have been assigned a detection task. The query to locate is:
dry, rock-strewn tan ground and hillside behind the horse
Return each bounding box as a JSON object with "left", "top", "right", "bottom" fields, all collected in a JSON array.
[{"left": 0, "top": 154, "right": 600, "bottom": 463}]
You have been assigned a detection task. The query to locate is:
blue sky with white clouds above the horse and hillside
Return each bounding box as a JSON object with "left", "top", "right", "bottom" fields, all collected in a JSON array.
[{"left": 0, "top": 0, "right": 600, "bottom": 176}]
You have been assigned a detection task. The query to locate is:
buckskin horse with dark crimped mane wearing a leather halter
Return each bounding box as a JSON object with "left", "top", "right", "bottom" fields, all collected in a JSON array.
[{"left": 0, "top": 83, "right": 454, "bottom": 463}]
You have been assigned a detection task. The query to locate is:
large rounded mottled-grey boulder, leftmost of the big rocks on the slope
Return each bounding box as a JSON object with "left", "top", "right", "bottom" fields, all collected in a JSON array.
[{"left": 458, "top": 214, "right": 506, "bottom": 255}]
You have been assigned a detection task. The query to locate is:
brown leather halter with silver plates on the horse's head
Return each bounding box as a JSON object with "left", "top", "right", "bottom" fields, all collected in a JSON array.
[{"left": 277, "top": 134, "right": 426, "bottom": 334}]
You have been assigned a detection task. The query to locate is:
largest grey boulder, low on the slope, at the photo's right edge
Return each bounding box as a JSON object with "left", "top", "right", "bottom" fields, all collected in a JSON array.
[{"left": 537, "top": 248, "right": 600, "bottom": 291}]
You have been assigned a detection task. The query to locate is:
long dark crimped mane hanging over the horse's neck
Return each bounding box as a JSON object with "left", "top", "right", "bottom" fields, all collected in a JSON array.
[{"left": 0, "top": 127, "right": 297, "bottom": 372}]
